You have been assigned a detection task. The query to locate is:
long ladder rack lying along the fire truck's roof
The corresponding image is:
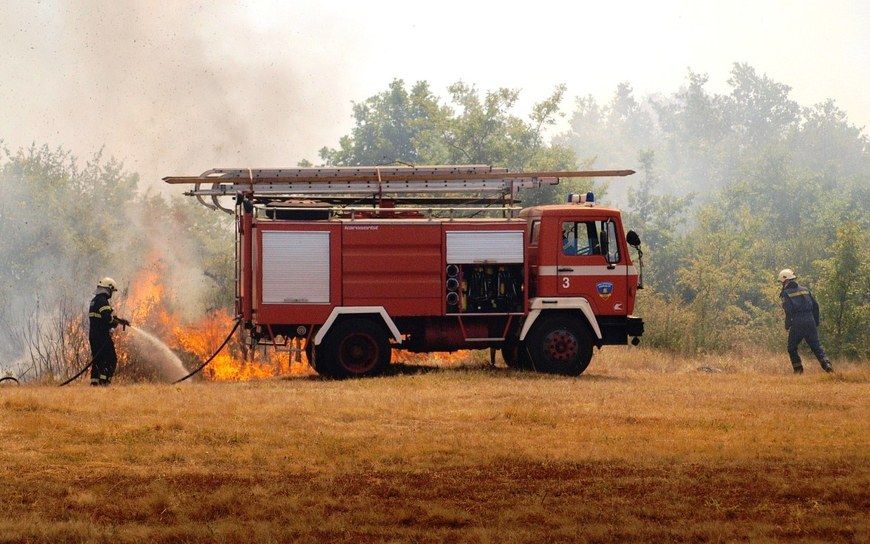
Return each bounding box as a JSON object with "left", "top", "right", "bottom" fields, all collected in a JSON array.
[{"left": 163, "top": 165, "right": 634, "bottom": 213}]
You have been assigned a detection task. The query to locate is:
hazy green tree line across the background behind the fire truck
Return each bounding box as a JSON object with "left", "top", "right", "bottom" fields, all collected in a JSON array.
[{"left": 0, "top": 64, "right": 870, "bottom": 373}]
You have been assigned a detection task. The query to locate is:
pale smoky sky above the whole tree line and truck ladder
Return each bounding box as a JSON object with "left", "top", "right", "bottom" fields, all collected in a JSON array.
[{"left": 0, "top": 0, "right": 870, "bottom": 187}]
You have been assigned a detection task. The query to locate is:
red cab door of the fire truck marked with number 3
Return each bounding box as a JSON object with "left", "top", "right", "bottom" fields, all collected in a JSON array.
[{"left": 556, "top": 216, "right": 627, "bottom": 315}]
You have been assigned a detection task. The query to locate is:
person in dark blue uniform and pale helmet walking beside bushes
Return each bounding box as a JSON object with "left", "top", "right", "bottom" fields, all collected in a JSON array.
[{"left": 779, "top": 268, "right": 834, "bottom": 374}]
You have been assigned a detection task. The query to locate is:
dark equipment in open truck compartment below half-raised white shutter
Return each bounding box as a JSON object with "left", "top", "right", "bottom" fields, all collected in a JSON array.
[{"left": 445, "top": 264, "right": 523, "bottom": 314}]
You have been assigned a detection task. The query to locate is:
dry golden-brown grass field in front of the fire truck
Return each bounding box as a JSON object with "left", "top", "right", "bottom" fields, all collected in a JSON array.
[{"left": 0, "top": 348, "right": 870, "bottom": 544}]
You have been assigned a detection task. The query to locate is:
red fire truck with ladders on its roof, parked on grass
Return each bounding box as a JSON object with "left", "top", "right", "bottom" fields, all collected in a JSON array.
[{"left": 164, "top": 166, "right": 643, "bottom": 377}]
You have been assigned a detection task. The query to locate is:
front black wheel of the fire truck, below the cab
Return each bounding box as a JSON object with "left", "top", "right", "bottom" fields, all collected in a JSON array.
[{"left": 526, "top": 315, "right": 593, "bottom": 376}]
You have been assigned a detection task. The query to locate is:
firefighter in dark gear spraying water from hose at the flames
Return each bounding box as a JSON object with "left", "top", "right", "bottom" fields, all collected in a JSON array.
[{"left": 88, "top": 278, "right": 130, "bottom": 385}]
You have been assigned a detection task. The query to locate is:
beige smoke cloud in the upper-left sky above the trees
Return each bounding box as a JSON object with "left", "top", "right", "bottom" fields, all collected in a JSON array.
[{"left": 0, "top": 0, "right": 364, "bottom": 185}]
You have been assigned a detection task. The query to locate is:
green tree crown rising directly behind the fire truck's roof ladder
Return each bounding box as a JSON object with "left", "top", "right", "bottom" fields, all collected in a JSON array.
[{"left": 316, "top": 79, "right": 594, "bottom": 205}]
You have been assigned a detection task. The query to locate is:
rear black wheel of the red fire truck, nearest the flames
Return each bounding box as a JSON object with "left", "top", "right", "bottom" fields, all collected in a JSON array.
[{"left": 315, "top": 319, "right": 391, "bottom": 378}]
